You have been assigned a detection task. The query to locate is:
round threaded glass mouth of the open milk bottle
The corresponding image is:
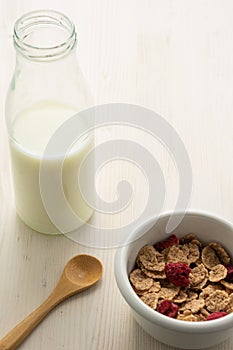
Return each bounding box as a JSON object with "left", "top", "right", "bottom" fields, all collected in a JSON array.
[{"left": 14, "top": 10, "right": 76, "bottom": 60}]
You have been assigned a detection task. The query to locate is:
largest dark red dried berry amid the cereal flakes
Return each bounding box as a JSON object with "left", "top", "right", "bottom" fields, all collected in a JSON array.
[{"left": 165, "top": 262, "right": 191, "bottom": 287}]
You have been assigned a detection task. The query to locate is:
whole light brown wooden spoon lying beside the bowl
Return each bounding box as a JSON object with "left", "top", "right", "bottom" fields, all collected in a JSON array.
[{"left": 0, "top": 254, "right": 103, "bottom": 350}]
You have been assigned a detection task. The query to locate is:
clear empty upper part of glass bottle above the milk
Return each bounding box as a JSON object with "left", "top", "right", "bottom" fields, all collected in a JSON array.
[{"left": 7, "top": 11, "right": 92, "bottom": 123}]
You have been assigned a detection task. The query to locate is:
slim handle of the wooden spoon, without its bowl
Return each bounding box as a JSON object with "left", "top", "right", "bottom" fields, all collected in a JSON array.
[{"left": 0, "top": 288, "right": 68, "bottom": 350}]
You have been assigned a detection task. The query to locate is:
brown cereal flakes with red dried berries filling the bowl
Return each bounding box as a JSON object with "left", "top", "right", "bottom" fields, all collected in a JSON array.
[{"left": 129, "top": 233, "right": 233, "bottom": 322}]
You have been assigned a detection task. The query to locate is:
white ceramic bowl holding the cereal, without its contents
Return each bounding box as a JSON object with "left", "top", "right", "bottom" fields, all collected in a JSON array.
[{"left": 115, "top": 211, "right": 233, "bottom": 349}]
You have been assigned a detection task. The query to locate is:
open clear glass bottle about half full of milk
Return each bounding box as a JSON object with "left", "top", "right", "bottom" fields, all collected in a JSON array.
[{"left": 6, "top": 10, "right": 94, "bottom": 234}]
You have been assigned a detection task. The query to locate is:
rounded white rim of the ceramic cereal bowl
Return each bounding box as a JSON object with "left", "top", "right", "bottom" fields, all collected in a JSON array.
[{"left": 114, "top": 209, "right": 233, "bottom": 334}]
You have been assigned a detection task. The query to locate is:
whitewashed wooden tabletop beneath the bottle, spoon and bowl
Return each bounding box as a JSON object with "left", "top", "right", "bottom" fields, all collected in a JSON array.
[{"left": 0, "top": 0, "right": 233, "bottom": 350}]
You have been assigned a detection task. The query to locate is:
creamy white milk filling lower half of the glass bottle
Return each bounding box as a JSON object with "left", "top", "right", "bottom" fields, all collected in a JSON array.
[{"left": 10, "top": 101, "right": 94, "bottom": 234}]
